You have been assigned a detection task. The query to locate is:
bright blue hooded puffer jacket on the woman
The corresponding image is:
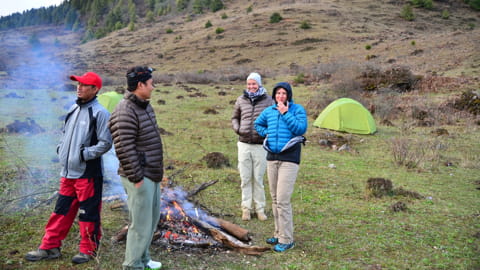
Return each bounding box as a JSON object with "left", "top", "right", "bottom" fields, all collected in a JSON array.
[{"left": 255, "top": 82, "right": 308, "bottom": 154}]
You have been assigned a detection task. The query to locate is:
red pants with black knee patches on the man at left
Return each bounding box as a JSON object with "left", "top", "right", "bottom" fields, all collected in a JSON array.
[{"left": 40, "top": 177, "right": 103, "bottom": 255}]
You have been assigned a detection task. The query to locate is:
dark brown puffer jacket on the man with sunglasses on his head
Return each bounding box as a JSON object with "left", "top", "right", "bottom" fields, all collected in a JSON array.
[{"left": 108, "top": 92, "right": 163, "bottom": 183}]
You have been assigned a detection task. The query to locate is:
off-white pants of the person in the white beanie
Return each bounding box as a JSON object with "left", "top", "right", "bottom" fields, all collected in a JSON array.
[{"left": 237, "top": 142, "right": 267, "bottom": 212}]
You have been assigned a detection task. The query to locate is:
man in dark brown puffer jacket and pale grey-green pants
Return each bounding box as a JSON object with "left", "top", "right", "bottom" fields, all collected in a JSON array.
[{"left": 109, "top": 66, "right": 163, "bottom": 270}]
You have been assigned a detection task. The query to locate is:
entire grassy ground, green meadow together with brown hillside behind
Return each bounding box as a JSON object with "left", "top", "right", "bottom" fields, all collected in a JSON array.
[{"left": 0, "top": 0, "right": 480, "bottom": 270}]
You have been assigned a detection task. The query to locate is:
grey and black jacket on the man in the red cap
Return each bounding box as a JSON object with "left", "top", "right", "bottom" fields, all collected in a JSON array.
[{"left": 57, "top": 97, "right": 112, "bottom": 179}]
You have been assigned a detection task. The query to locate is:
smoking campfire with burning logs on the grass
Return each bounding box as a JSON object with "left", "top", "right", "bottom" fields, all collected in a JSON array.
[{"left": 113, "top": 181, "right": 270, "bottom": 255}]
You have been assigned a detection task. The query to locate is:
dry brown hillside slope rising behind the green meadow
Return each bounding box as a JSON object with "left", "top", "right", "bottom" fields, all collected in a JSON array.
[{"left": 0, "top": 0, "right": 480, "bottom": 89}]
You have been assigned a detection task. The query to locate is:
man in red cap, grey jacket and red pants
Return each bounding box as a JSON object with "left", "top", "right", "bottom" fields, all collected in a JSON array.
[{"left": 25, "top": 72, "right": 112, "bottom": 264}]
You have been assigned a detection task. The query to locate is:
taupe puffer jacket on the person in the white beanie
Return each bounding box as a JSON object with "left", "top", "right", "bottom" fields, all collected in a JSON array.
[{"left": 232, "top": 94, "right": 273, "bottom": 144}]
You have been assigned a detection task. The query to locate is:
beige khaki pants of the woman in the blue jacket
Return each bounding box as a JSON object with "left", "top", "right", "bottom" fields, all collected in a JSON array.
[{"left": 267, "top": 160, "right": 299, "bottom": 244}]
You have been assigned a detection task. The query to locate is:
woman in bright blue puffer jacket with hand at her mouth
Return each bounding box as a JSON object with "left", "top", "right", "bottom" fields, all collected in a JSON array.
[{"left": 255, "top": 82, "right": 307, "bottom": 252}]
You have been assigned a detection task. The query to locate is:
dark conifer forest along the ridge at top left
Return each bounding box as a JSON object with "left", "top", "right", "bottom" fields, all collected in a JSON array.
[{"left": 0, "top": 0, "right": 225, "bottom": 41}]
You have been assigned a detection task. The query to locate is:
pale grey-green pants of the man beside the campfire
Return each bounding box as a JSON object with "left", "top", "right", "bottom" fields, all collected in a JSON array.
[{"left": 121, "top": 177, "right": 161, "bottom": 270}]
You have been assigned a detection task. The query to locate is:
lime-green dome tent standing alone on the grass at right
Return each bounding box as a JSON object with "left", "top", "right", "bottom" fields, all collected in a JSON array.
[{"left": 313, "top": 98, "right": 377, "bottom": 134}]
